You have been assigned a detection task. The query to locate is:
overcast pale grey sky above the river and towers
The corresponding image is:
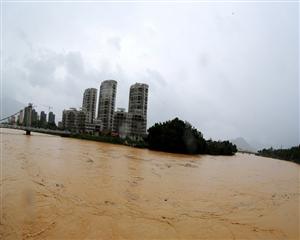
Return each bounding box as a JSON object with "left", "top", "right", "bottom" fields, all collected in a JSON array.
[{"left": 2, "top": 2, "right": 299, "bottom": 147}]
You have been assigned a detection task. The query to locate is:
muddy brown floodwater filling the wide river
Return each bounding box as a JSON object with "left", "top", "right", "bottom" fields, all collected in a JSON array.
[{"left": 0, "top": 129, "right": 300, "bottom": 239}]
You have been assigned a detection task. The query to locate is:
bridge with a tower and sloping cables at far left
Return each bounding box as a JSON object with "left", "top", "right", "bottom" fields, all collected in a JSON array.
[{"left": 0, "top": 103, "right": 71, "bottom": 136}]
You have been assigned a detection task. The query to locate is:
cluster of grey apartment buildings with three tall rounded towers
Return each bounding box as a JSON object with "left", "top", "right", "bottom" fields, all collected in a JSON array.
[{"left": 61, "top": 80, "right": 149, "bottom": 140}]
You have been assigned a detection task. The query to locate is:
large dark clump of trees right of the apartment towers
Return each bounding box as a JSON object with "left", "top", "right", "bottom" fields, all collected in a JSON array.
[{"left": 146, "top": 118, "right": 237, "bottom": 155}]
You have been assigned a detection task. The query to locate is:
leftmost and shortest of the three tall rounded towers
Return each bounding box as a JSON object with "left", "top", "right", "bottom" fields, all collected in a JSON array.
[{"left": 82, "top": 88, "right": 97, "bottom": 123}]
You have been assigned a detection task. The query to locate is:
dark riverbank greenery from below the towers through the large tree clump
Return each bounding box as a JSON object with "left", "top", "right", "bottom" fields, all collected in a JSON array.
[{"left": 69, "top": 118, "right": 237, "bottom": 155}]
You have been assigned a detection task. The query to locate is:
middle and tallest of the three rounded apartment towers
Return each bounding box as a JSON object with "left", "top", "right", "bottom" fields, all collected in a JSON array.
[{"left": 98, "top": 80, "right": 117, "bottom": 132}]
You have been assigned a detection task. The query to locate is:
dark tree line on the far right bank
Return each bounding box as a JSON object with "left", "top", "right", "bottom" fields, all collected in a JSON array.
[{"left": 257, "top": 145, "right": 300, "bottom": 164}]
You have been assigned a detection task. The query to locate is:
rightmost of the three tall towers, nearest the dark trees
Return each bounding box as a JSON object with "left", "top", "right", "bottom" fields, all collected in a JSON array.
[{"left": 128, "top": 83, "right": 149, "bottom": 136}]
